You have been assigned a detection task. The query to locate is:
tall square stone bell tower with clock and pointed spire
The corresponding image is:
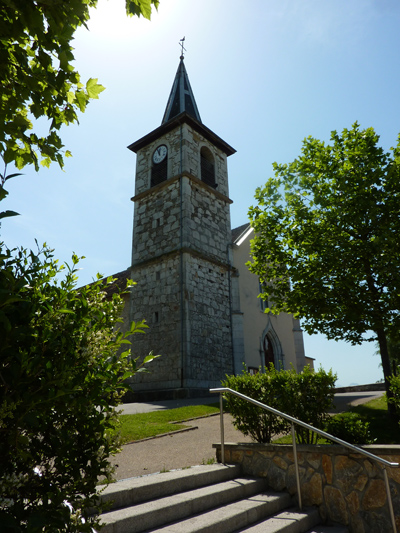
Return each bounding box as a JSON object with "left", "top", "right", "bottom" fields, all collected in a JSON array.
[{"left": 128, "top": 56, "right": 235, "bottom": 396}]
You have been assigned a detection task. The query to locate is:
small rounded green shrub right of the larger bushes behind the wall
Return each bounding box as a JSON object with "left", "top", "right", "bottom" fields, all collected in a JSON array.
[{"left": 325, "top": 412, "right": 373, "bottom": 444}]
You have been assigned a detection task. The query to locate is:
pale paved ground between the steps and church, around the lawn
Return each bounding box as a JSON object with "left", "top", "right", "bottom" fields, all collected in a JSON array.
[{"left": 112, "top": 392, "right": 383, "bottom": 480}]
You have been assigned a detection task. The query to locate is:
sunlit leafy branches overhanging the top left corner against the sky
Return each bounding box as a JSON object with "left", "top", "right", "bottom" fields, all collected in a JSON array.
[{"left": 0, "top": 0, "right": 159, "bottom": 170}]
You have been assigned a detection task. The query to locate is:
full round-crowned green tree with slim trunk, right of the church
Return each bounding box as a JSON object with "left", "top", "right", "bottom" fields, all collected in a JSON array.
[{"left": 249, "top": 123, "right": 400, "bottom": 416}]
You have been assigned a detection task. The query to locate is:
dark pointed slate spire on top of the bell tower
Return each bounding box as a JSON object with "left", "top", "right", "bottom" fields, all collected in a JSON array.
[{"left": 161, "top": 55, "right": 201, "bottom": 124}]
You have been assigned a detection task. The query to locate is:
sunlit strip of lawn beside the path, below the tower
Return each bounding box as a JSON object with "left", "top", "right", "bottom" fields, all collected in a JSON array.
[{"left": 118, "top": 404, "right": 219, "bottom": 444}]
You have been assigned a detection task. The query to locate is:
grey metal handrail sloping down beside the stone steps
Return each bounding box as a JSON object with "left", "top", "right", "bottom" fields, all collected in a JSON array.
[{"left": 210, "top": 387, "right": 400, "bottom": 533}]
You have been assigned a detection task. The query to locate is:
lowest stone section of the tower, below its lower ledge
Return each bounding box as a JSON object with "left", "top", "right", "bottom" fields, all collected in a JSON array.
[{"left": 131, "top": 247, "right": 233, "bottom": 390}]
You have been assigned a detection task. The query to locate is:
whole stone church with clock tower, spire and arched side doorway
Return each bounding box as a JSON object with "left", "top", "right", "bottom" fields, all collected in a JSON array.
[{"left": 115, "top": 55, "right": 311, "bottom": 399}]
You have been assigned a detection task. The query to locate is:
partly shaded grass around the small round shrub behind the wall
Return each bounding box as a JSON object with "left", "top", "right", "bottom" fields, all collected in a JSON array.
[{"left": 274, "top": 395, "right": 400, "bottom": 444}]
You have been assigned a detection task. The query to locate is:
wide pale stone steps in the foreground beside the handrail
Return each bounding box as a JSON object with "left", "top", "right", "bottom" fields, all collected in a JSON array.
[{"left": 97, "top": 464, "right": 348, "bottom": 533}]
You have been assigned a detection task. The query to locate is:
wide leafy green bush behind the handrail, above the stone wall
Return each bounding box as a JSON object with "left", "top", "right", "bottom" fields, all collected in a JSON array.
[{"left": 222, "top": 365, "right": 336, "bottom": 443}]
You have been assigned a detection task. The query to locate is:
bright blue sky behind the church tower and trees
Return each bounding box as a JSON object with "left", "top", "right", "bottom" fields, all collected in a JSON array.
[{"left": 2, "top": 0, "right": 400, "bottom": 385}]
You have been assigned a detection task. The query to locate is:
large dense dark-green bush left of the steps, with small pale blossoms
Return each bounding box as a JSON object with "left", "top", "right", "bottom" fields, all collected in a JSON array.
[{"left": 0, "top": 245, "right": 158, "bottom": 533}]
